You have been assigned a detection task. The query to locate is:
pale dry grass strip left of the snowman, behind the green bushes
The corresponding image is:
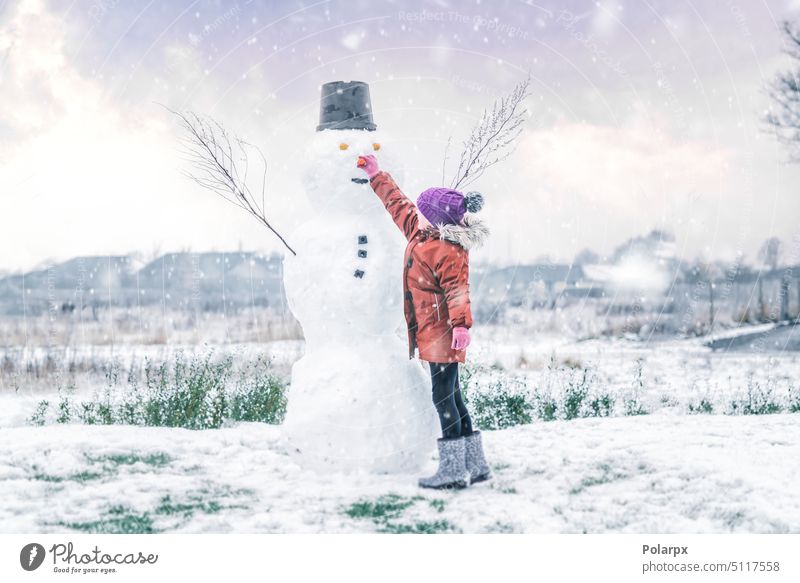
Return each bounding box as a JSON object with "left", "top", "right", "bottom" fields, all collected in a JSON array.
[{"left": 0, "top": 308, "right": 303, "bottom": 392}]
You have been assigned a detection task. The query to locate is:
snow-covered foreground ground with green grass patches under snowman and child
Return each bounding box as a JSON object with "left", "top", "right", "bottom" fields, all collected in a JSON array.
[{"left": 0, "top": 415, "right": 800, "bottom": 533}]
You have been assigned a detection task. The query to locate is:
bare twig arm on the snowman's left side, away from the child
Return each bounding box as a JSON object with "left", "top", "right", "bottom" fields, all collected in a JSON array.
[{"left": 164, "top": 107, "right": 297, "bottom": 255}]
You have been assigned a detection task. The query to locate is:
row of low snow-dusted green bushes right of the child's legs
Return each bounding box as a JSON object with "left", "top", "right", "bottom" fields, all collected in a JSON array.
[{"left": 462, "top": 353, "right": 800, "bottom": 429}]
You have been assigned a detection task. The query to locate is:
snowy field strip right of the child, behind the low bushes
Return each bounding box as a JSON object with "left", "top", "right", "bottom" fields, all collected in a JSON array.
[{"left": 473, "top": 325, "right": 800, "bottom": 414}]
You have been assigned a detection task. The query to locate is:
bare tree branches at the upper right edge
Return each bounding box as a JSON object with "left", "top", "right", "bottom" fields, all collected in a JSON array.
[{"left": 764, "top": 22, "right": 800, "bottom": 162}]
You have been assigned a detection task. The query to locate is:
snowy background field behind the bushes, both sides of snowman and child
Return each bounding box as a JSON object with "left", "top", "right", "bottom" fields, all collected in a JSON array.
[{"left": 0, "top": 326, "right": 800, "bottom": 427}]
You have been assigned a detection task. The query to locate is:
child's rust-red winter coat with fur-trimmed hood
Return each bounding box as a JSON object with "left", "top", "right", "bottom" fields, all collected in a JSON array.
[{"left": 370, "top": 172, "right": 488, "bottom": 363}]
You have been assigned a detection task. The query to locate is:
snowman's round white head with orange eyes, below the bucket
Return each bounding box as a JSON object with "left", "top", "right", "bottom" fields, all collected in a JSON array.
[{"left": 304, "top": 130, "right": 400, "bottom": 214}]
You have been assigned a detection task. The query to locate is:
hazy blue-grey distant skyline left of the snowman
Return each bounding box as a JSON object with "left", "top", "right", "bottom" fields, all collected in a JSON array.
[{"left": 0, "top": 252, "right": 287, "bottom": 315}]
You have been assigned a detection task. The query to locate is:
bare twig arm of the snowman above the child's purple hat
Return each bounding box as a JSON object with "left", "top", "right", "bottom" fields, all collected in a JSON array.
[{"left": 445, "top": 76, "right": 530, "bottom": 189}]
